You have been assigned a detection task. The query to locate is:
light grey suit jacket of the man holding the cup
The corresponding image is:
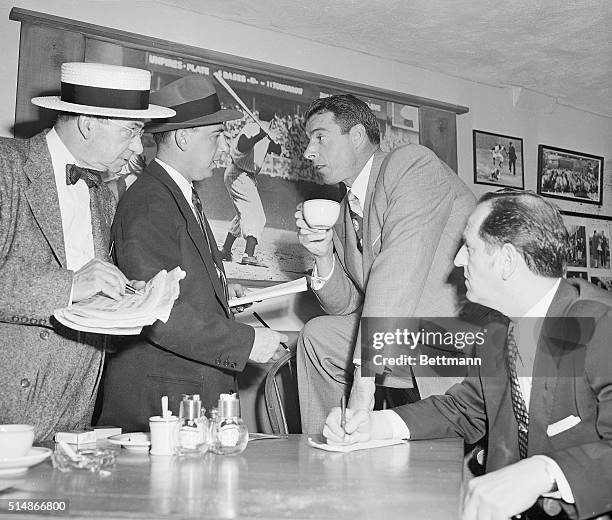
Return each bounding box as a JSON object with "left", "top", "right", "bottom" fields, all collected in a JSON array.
[{"left": 316, "top": 144, "right": 475, "bottom": 396}]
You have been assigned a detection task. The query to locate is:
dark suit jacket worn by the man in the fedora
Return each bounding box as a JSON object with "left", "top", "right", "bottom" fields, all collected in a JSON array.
[{"left": 99, "top": 161, "right": 255, "bottom": 431}]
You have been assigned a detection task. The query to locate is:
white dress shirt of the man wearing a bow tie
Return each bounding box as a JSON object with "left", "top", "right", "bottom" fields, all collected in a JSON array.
[{"left": 46, "top": 128, "right": 95, "bottom": 270}]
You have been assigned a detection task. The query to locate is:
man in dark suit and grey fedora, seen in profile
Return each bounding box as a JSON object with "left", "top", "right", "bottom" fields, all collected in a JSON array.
[{"left": 99, "top": 76, "right": 286, "bottom": 431}]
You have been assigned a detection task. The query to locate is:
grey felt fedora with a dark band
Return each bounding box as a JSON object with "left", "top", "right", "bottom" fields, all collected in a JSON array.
[{"left": 145, "top": 76, "right": 244, "bottom": 134}]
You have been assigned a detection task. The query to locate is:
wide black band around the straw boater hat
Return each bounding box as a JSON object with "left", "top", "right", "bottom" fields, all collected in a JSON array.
[{"left": 61, "top": 82, "right": 149, "bottom": 110}]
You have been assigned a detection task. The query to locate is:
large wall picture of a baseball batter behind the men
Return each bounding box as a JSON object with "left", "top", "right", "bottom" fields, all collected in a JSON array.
[{"left": 86, "top": 40, "right": 419, "bottom": 281}]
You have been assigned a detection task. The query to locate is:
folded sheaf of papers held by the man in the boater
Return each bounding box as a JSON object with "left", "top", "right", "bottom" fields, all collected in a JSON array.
[{"left": 53, "top": 267, "right": 185, "bottom": 335}]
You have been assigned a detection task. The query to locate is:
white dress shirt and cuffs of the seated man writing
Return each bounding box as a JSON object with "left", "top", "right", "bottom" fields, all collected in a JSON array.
[{"left": 382, "top": 278, "right": 574, "bottom": 504}]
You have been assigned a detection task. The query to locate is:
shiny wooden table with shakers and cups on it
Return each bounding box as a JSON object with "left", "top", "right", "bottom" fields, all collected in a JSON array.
[{"left": 0, "top": 435, "right": 463, "bottom": 520}]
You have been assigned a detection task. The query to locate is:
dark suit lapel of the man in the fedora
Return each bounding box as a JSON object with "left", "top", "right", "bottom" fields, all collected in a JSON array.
[{"left": 147, "top": 161, "right": 228, "bottom": 314}]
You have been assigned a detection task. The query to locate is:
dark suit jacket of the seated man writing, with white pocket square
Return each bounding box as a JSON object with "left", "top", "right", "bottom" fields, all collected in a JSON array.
[{"left": 395, "top": 279, "right": 612, "bottom": 518}]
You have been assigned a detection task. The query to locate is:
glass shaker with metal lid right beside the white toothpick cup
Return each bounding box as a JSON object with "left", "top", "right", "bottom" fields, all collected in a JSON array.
[{"left": 176, "top": 394, "right": 208, "bottom": 455}]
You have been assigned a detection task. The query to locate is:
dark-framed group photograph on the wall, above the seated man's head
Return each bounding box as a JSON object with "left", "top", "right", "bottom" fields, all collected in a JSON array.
[{"left": 537, "top": 144, "right": 604, "bottom": 206}]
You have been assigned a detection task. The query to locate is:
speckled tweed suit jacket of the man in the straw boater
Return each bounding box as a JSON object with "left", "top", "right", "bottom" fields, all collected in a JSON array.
[{"left": 0, "top": 131, "right": 114, "bottom": 440}]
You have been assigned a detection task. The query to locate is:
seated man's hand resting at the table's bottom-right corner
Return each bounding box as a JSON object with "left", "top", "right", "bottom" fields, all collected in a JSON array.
[{"left": 462, "top": 458, "right": 552, "bottom": 520}]
